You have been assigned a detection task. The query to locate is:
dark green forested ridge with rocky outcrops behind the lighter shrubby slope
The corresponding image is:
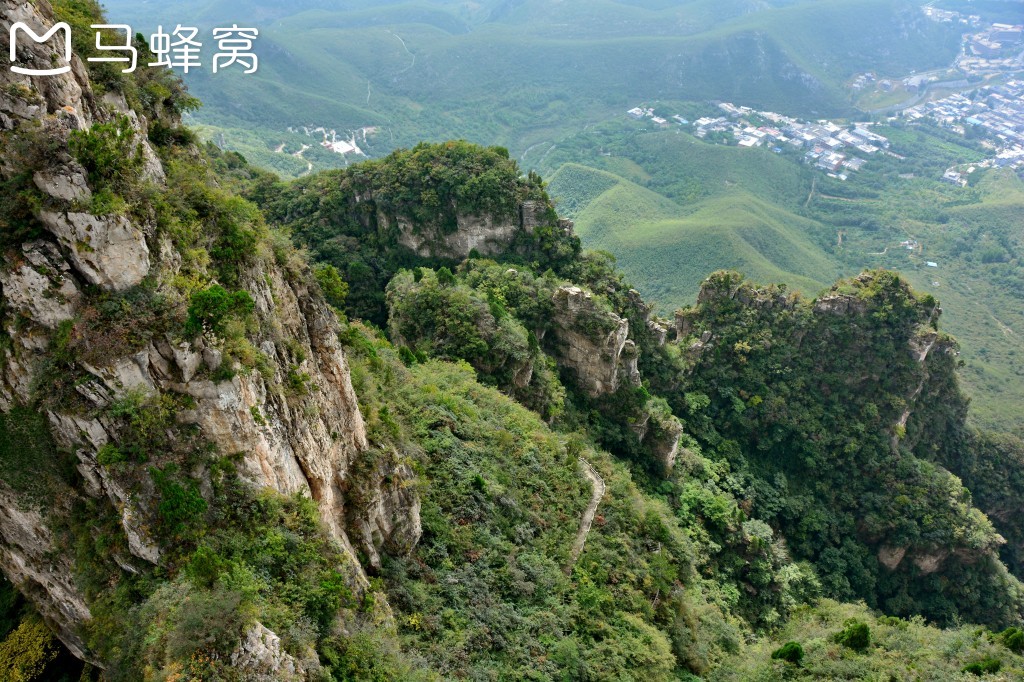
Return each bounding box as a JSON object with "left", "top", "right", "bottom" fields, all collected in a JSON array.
[{"left": 245, "top": 134, "right": 1021, "bottom": 624}]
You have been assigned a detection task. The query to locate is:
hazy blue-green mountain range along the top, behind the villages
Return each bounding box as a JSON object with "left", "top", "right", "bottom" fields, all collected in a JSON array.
[{"left": 106, "top": 0, "right": 959, "bottom": 175}]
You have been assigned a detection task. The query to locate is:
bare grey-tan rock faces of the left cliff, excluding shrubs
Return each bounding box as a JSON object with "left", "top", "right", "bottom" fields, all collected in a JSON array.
[{"left": 0, "top": 0, "right": 420, "bottom": 667}]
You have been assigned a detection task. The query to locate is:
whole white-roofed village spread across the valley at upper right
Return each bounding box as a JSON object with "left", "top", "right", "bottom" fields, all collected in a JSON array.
[{"left": 628, "top": 5, "right": 1024, "bottom": 186}]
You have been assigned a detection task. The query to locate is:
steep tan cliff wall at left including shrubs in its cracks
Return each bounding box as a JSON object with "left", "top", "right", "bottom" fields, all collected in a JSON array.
[{"left": 0, "top": 0, "right": 420, "bottom": 665}]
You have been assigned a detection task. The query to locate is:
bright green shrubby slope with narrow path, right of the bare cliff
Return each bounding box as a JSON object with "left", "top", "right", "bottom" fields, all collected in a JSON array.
[{"left": 346, "top": 326, "right": 741, "bottom": 682}]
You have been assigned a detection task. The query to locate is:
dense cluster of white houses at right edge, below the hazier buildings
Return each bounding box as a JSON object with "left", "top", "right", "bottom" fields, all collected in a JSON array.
[{"left": 902, "top": 80, "right": 1024, "bottom": 179}]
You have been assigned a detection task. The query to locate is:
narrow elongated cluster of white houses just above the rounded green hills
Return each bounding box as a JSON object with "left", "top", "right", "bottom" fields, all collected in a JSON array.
[{"left": 627, "top": 102, "right": 889, "bottom": 180}]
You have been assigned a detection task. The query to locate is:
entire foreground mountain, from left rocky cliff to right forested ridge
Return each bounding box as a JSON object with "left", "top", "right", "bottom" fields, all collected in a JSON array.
[{"left": 0, "top": 0, "right": 1024, "bottom": 680}]
